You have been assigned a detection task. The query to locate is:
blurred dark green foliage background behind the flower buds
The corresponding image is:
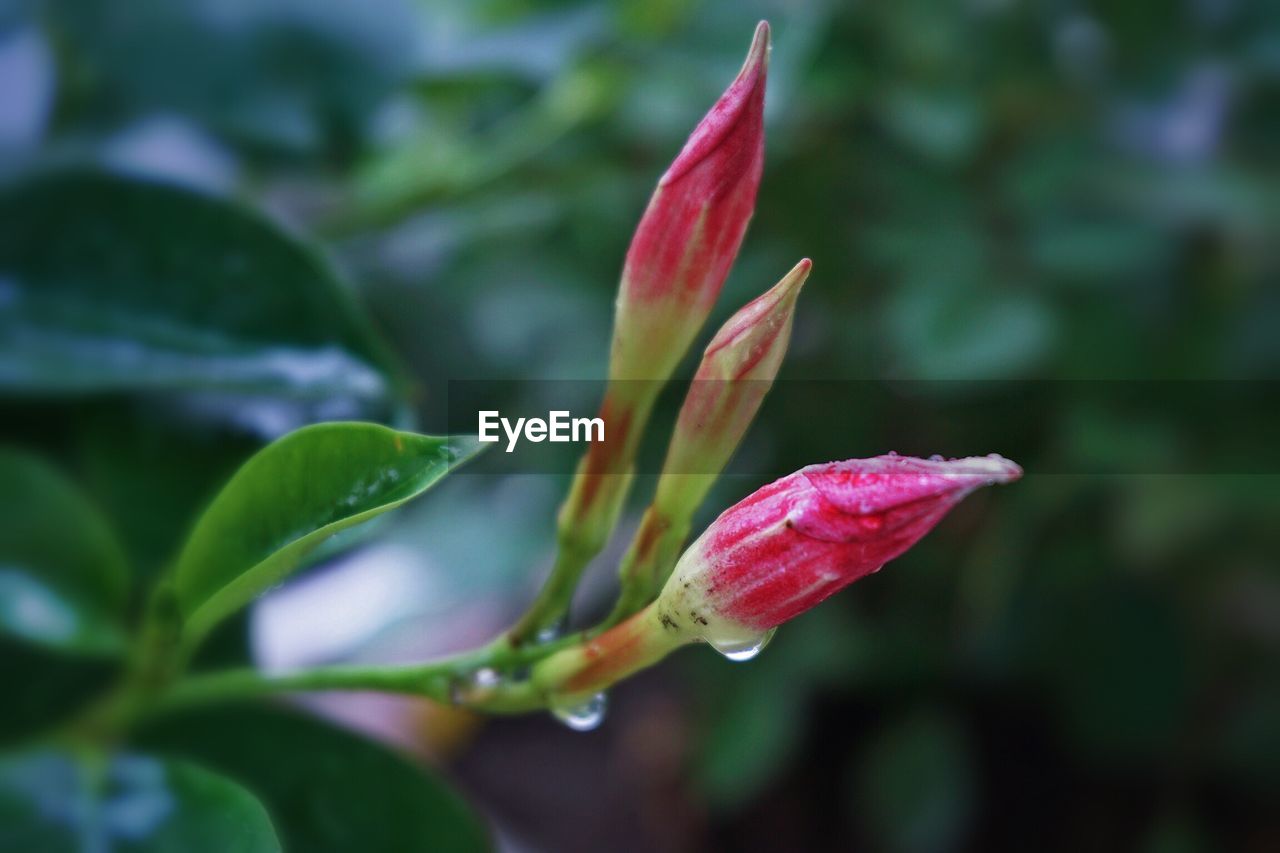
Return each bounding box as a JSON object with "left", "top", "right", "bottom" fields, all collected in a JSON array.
[{"left": 0, "top": 0, "right": 1280, "bottom": 853}]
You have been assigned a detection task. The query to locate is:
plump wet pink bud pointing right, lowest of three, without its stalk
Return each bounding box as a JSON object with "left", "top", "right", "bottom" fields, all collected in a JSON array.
[{"left": 658, "top": 455, "right": 1023, "bottom": 648}]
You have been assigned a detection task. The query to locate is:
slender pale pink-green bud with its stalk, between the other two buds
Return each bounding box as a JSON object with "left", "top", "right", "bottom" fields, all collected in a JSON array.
[{"left": 608, "top": 257, "right": 812, "bottom": 624}]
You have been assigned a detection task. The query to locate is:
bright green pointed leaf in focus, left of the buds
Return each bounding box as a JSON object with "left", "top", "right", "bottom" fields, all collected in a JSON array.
[{"left": 174, "top": 423, "right": 484, "bottom": 640}]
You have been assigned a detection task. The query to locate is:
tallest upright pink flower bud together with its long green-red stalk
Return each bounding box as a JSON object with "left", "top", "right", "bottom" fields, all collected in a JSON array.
[{"left": 509, "top": 20, "right": 769, "bottom": 644}]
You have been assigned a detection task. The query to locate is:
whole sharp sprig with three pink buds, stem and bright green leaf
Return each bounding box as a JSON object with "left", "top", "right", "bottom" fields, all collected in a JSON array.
[{"left": 62, "top": 23, "right": 1021, "bottom": 726}]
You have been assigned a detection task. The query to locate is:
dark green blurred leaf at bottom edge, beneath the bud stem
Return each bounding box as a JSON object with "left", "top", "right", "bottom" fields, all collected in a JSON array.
[{"left": 140, "top": 707, "right": 492, "bottom": 853}]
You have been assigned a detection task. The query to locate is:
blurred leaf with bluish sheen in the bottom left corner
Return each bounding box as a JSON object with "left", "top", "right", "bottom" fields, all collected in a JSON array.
[{"left": 0, "top": 751, "right": 280, "bottom": 853}]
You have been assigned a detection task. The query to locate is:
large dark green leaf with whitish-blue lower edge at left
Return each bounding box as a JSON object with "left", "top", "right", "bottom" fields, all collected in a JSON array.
[{"left": 0, "top": 170, "right": 398, "bottom": 420}]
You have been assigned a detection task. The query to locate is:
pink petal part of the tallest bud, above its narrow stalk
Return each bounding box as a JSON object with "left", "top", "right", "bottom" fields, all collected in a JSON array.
[{"left": 609, "top": 20, "right": 769, "bottom": 379}]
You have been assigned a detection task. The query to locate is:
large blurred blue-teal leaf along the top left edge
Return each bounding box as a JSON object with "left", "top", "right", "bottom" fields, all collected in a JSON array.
[{"left": 46, "top": 0, "right": 415, "bottom": 154}]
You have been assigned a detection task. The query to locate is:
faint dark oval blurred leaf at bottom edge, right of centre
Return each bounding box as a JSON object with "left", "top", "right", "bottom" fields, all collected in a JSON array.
[{"left": 851, "top": 712, "right": 974, "bottom": 850}]
